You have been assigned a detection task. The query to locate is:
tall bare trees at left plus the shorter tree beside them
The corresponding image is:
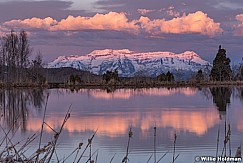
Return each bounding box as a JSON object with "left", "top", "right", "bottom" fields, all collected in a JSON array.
[{"left": 0, "top": 30, "right": 44, "bottom": 84}]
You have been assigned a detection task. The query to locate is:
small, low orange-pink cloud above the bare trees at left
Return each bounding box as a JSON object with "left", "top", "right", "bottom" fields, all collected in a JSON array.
[{"left": 3, "top": 17, "right": 57, "bottom": 29}]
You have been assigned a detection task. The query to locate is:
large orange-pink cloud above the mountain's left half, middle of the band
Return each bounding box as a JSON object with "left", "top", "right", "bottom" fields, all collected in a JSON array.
[{"left": 50, "top": 12, "right": 139, "bottom": 33}]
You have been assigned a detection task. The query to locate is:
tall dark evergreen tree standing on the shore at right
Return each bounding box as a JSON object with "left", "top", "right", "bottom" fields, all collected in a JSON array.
[{"left": 210, "top": 45, "right": 232, "bottom": 81}]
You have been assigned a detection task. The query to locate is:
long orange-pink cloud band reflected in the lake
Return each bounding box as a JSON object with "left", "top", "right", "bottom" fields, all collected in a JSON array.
[{"left": 27, "top": 108, "right": 219, "bottom": 137}]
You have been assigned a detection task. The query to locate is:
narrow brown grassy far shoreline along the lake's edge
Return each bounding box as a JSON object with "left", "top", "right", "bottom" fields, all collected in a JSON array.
[{"left": 0, "top": 81, "right": 243, "bottom": 89}]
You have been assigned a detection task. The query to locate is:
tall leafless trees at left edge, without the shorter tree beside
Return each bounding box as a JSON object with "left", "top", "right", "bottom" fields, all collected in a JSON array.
[{"left": 0, "top": 30, "right": 32, "bottom": 83}]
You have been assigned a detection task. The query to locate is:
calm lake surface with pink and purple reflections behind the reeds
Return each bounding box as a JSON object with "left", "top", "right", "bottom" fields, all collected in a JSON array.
[{"left": 0, "top": 88, "right": 243, "bottom": 163}]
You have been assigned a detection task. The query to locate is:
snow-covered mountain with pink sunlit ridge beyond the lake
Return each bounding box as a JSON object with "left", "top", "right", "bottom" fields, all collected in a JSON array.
[{"left": 48, "top": 49, "right": 211, "bottom": 77}]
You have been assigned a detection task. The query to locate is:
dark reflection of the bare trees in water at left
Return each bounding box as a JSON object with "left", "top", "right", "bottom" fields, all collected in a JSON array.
[{"left": 0, "top": 89, "right": 47, "bottom": 131}]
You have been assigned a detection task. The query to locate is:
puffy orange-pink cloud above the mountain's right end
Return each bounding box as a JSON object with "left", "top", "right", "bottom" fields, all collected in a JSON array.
[{"left": 139, "top": 11, "right": 223, "bottom": 36}]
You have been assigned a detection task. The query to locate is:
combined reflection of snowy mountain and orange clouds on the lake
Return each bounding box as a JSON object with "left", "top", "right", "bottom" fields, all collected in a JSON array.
[{"left": 23, "top": 88, "right": 219, "bottom": 137}]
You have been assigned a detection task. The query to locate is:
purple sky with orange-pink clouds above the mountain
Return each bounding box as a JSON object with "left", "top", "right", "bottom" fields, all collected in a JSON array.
[{"left": 0, "top": 0, "right": 243, "bottom": 64}]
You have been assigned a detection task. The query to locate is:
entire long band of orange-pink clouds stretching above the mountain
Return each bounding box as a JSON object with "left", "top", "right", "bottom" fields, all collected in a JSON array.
[{"left": 0, "top": 11, "right": 223, "bottom": 37}]
